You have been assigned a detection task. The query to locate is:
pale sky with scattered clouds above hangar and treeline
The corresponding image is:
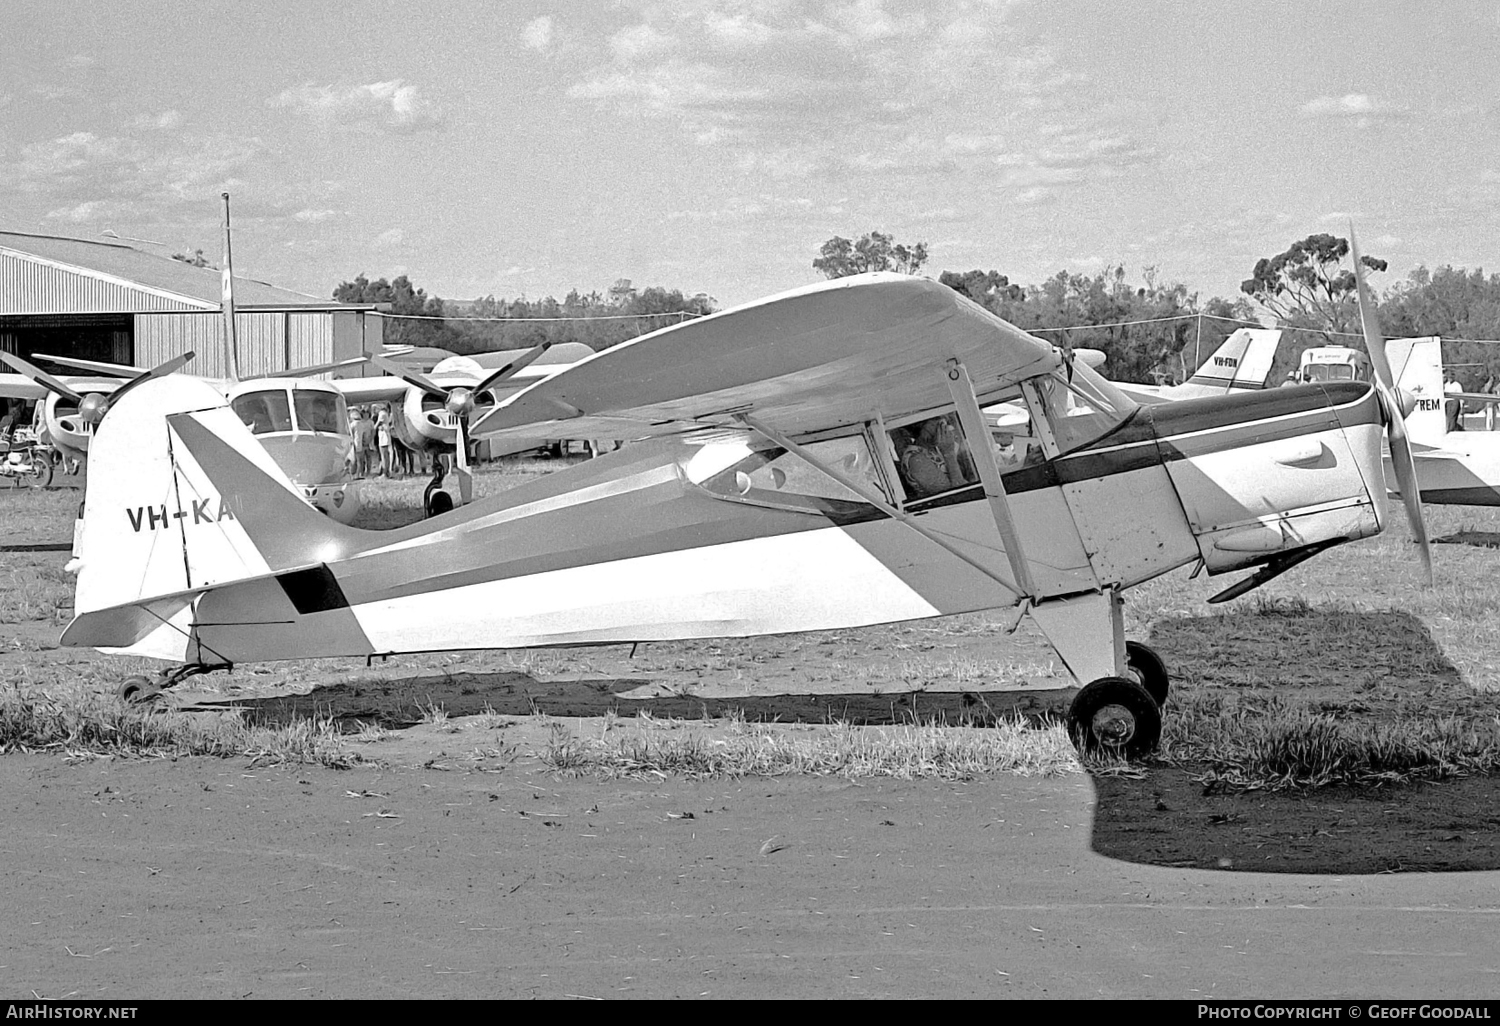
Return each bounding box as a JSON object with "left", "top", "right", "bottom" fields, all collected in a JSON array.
[{"left": 0, "top": 0, "right": 1500, "bottom": 306}]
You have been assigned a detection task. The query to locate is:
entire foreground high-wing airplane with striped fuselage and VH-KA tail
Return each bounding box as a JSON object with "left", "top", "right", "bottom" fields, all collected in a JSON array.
[{"left": 63, "top": 261, "right": 1425, "bottom": 755}]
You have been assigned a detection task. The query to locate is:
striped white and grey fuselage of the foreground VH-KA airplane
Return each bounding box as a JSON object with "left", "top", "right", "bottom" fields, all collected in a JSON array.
[{"left": 65, "top": 384, "right": 1385, "bottom": 663}]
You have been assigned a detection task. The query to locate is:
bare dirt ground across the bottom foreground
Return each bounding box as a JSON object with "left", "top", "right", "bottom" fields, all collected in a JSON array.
[{"left": 0, "top": 756, "right": 1500, "bottom": 1001}]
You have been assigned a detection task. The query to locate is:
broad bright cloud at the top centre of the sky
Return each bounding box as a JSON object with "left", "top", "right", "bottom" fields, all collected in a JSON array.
[{"left": 569, "top": 0, "right": 1044, "bottom": 152}]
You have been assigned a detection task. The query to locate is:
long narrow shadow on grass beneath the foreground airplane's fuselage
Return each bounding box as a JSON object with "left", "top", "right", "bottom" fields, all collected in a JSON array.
[{"left": 196, "top": 672, "right": 1074, "bottom": 731}]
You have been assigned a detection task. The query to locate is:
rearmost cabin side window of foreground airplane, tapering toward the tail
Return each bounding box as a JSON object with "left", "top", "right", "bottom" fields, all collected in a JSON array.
[{"left": 702, "top": 435, "right": 890, "bottom": 513}]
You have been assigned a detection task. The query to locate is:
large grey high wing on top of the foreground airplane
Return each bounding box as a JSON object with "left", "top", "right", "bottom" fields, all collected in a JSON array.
[{"left": 474, "top": 273, "right": 1062, "bottom": 438}]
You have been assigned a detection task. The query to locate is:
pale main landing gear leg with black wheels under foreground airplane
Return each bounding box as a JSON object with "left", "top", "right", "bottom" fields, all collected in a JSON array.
[{"left": 1031, "top": 590, "right": 1167, "bottom": 759}]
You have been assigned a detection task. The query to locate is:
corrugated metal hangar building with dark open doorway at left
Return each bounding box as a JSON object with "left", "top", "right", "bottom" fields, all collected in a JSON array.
[{"left": 0, "top": 231, "right": 383, "bottom": 377}]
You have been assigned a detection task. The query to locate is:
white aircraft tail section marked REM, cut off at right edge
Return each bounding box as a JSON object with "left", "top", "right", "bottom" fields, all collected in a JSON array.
[{"left": 1386, "top": 336, "right": 1500, "bottom": 506}]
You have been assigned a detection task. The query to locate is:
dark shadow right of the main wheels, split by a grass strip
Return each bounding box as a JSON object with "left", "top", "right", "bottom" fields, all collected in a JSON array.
[{"left": 1092, "top": 603, "right": 1500, "bottom": 875}]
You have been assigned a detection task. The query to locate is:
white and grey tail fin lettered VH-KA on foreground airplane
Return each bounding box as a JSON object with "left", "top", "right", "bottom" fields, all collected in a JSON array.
[{"left": 63, "top": 377, "right": 359, "bottom": 657}]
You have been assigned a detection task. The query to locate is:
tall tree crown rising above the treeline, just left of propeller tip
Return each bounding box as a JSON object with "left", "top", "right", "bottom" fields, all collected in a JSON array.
[{"left": 1239, "top": 234, "right": 1386, "bottom": 342}]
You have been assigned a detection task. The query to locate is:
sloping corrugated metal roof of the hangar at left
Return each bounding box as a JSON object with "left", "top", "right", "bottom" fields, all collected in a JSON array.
[{"left": 0, "top": 231, "right": 354, "bottom": 314}]
